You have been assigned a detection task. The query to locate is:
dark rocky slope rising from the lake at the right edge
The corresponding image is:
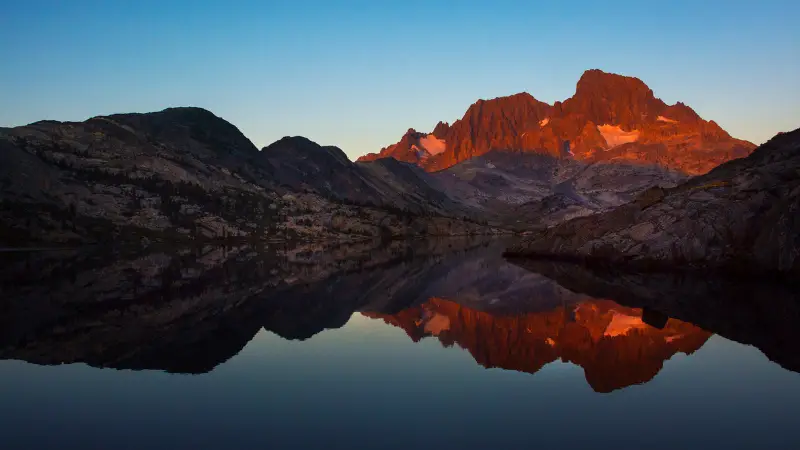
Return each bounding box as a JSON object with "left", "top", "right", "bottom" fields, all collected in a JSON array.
[{"left": 507, "top": 125, "right": 800, "bottom": 278}]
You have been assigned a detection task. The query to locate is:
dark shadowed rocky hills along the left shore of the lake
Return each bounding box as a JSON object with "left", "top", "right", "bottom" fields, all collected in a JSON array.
[{"left": 0, "top": 108, "right": 493, "bottom": 245}]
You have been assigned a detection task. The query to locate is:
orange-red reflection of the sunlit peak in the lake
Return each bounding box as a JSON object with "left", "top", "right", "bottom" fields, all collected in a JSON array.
[{"left": 363, "top": 298, "right": 711, "bottom": 392}]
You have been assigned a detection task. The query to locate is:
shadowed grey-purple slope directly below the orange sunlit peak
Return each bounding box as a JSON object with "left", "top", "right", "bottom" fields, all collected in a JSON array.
[{"left": 428, "top": 150, "right": 688, "bottom": 230}]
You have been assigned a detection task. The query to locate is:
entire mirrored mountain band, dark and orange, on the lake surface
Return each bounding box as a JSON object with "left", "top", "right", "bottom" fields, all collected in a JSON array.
[{"left": 0, "top": 239, "right": 800, "bottom": 386}]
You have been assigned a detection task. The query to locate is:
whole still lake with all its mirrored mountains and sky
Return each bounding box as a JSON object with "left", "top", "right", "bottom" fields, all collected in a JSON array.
[{"left": 0, "top": 240, "right": 800, "bottom": 449}]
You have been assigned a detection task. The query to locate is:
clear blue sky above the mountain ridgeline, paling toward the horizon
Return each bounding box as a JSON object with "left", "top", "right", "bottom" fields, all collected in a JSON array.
[{"left": 0, "top": 0, "right": 800, "bottom": 158}]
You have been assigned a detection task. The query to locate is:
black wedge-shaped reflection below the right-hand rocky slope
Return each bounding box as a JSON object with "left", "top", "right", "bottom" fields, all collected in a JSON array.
[{"left": 511, "top": 260, "right": 800, "bottom": 372}]
